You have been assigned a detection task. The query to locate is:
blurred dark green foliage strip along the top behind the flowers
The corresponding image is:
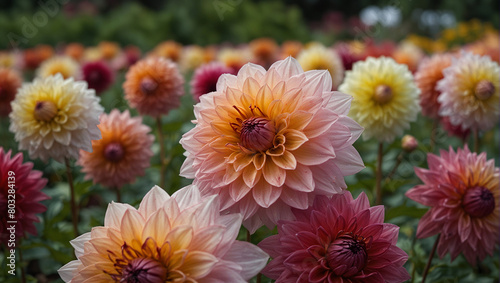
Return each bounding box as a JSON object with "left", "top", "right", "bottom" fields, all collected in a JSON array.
[{"left": 0, "top": 0, "right": 499, "bottom": 50}]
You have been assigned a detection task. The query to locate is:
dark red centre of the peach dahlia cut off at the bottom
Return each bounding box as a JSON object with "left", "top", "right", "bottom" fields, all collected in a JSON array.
[{"left": 119, "top": 258, "right": 167, "bottom": 283}]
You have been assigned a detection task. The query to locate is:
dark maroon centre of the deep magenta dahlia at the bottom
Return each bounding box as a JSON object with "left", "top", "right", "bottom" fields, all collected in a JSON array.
[{"left": 326, "top": 235, "right": 368, "bottom": 277}]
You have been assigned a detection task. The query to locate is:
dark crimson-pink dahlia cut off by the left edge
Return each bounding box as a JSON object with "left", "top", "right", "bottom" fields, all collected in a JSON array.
[{"left": 0, "top": 147, "right": 49, "bottom": 246}]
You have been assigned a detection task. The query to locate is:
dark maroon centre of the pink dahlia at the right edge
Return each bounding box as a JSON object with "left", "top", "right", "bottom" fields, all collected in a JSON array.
[{"left": 462, "top": 187, "right": 495, "bottom": 218}]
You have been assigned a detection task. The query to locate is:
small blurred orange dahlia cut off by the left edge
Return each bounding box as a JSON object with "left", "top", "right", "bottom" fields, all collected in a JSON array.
[{"left": 0, "top": 67, "right": 22, "bottom": 117}]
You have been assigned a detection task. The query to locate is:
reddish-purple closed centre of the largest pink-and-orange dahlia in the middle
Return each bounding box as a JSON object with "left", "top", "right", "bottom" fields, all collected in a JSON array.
[{"left": 240, "top": 117, "right": 276, "bottom": 151}]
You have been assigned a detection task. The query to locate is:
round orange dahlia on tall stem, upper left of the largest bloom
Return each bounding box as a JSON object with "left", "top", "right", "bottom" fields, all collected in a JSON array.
[{"left": 123, "top": 58, "right": 184, "bottom": 117}]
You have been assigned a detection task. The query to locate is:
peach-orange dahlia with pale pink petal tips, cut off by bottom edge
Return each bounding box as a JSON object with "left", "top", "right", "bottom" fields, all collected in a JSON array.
[{"left": 59, "top": 186, "right": 268, "bottom": 283}]
